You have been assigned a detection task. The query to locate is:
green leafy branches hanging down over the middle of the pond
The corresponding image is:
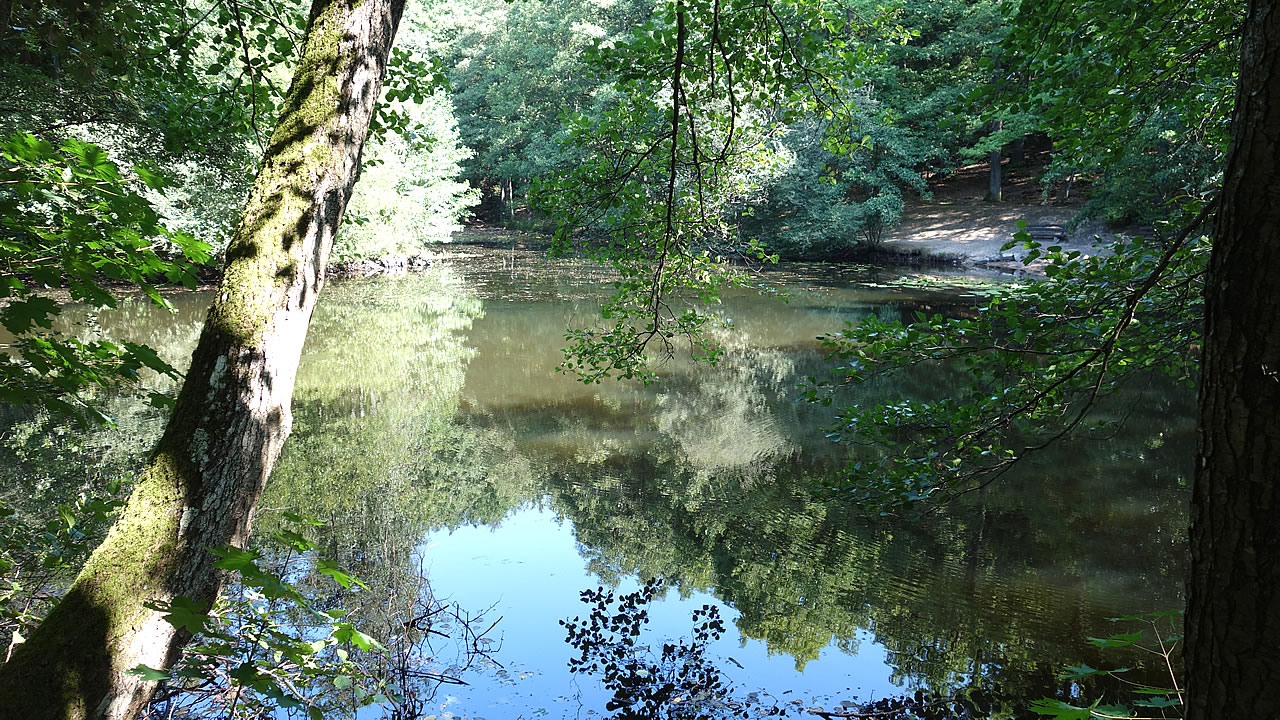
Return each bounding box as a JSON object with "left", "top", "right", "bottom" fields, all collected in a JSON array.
[{"left": 535, "top": 0, "right": 896, "bottom": 382}]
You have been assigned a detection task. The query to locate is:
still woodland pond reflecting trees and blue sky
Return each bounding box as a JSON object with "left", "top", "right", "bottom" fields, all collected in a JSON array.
[{"left": 5, "top": 244, "right": 1194, "bottom": 720}]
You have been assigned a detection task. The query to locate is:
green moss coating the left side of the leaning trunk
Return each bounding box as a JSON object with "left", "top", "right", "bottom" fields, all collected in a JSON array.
[{"left": 0, "top": 4, "right": 394, "bottom": 719}]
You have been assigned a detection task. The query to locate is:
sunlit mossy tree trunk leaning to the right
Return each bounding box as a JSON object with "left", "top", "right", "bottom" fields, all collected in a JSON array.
[{"left": 0, "top": 0, "right": 404, "bottom": 720}]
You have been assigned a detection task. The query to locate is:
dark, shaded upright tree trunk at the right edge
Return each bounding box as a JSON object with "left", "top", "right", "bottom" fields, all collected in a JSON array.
[{"left": 1184, "top": 0, "right": 1280, "bottom": 720}]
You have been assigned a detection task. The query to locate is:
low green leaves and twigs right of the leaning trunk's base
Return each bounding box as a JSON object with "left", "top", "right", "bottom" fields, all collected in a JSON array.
[{"left": 133, "top": 512, "right": 492, "bottom": 720}]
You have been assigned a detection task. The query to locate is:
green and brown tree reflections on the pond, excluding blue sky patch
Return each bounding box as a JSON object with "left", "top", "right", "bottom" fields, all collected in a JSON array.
[{"left": 0, "top": 252, "right": 1193, "bottom": 711}]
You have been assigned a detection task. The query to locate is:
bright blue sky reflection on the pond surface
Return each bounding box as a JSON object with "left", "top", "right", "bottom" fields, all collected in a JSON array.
[{"left": 425, "top": 506, "right": 895, "bottom": 719}]
